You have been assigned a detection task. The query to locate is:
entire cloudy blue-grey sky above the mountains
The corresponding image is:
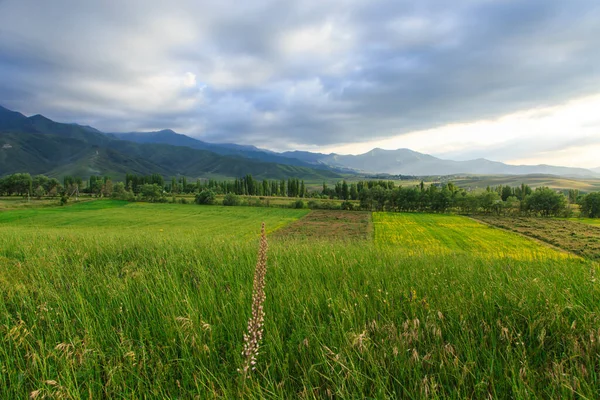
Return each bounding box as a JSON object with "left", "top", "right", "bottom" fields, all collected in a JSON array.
[{"left": 0, "top": 0, "right": 600, "bottom": 167}]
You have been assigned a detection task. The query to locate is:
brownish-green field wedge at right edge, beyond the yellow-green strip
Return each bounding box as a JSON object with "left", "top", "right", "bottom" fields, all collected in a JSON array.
[{"left": 477, "top": 216, "right": 600, "bottom": 260}]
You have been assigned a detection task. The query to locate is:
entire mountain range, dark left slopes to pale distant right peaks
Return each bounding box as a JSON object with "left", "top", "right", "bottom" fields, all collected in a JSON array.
[{"left": 0, "top": 107, "right": 600, "bottom": 180}]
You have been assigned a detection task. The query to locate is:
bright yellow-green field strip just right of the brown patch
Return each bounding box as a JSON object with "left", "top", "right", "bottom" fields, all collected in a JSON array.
[{"left": 373, "top": 213, "right": 567, "bottom": 260}]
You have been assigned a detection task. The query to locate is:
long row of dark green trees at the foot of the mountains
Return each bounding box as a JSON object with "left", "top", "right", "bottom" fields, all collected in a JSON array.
[{"left": 0, "top": 173, "right": 600, "bottom": 218}]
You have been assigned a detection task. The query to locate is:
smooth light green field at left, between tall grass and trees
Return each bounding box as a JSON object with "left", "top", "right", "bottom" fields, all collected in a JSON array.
[{"left": 0, "top": 200, "right": 309, "bottom": 238}]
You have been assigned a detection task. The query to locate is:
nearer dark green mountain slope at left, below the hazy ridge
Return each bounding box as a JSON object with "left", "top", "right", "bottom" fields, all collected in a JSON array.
[{"left": 0, "top": 108, "right": 340, "bottom": 180}]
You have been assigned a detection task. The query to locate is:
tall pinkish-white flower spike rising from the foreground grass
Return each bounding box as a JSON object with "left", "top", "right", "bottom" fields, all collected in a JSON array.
[{"left": 238, "top": 222, "right": 268, "bottom": 378}]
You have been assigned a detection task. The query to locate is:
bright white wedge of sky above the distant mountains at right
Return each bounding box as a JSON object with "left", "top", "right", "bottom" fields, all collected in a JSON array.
[{"left": 313, "top": 95, "right": 600, "bottom": 168}]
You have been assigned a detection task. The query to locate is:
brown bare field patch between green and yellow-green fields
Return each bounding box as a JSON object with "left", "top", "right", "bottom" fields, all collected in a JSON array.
[{"left": 274, "top": 210, "right": 373, "bottom": 240}]
